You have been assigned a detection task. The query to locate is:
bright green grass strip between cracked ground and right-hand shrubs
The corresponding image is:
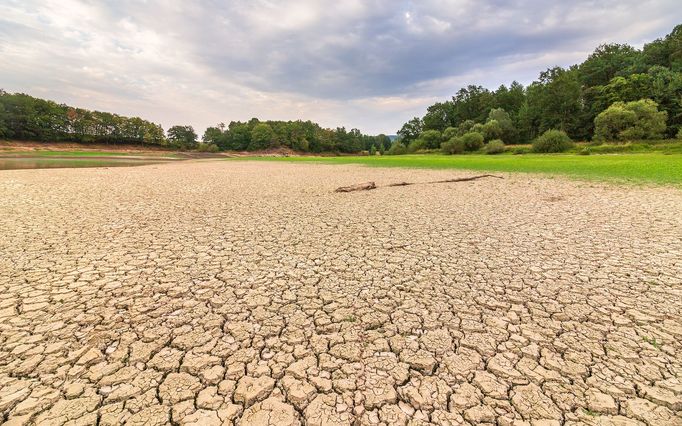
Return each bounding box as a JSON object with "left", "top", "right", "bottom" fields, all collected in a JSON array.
[{"left": 250, "top": 153, "right": 682, "bottom": 186}]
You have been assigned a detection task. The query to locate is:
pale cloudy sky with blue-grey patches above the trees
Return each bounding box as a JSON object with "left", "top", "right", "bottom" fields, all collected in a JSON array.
[{"left": 0, "top": 0, "right": 682, "bottom": 134}]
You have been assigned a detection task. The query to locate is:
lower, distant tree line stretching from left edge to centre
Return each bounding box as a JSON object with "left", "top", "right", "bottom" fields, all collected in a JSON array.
[{"left": 0, "top": 90, "right": 391, "bottom": 153}]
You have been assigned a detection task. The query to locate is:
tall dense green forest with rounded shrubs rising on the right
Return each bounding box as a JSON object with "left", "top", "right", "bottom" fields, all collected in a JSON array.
[{"left": 398, "top": 25, "right": 682, "bottom": 149}]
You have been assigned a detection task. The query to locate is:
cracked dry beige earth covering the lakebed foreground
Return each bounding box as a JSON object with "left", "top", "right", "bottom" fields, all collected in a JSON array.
[{"left": 0, "top": 161, "right": 682, "bottom": 425}]
